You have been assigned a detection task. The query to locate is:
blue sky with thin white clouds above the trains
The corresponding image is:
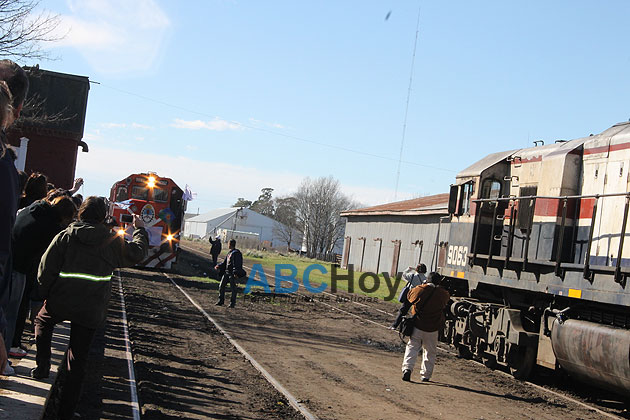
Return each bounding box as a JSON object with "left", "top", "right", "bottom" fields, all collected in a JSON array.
[{"left": 28, "top": 0, "right": 630, "bottom": 212}]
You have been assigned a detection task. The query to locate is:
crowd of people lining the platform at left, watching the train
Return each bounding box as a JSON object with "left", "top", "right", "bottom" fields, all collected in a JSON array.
[{"left": 0, "top": 60, "right": 148, "bottom": 420}]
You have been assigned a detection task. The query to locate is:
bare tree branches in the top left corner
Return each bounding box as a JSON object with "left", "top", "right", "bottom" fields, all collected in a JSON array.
[{"left": 0, "top": 0, "right": 63, "bottom": 59}]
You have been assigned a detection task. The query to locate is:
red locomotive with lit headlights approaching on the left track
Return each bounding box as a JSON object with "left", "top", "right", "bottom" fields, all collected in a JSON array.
[{"left": 110, "top": 172, "right": 186, "bottom": 269}]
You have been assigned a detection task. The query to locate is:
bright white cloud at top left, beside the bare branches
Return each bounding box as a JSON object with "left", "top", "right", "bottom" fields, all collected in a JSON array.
[{"left": 55, "top": 0, "right": 170, "bottom": 73}]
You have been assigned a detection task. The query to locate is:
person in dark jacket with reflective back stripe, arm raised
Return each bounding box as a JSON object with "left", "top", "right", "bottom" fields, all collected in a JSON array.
[{"left": 31, "top": 197, "right": 148, "bottom": 420}]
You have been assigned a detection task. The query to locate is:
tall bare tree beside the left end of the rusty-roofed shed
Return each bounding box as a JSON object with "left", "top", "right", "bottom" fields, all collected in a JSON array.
[{"left": 295, "top": 176, "right": 357, "bottom": 257}]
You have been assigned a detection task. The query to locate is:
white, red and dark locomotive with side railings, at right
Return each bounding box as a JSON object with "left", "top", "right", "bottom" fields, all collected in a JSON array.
[{"left": 440, "top": 123, "right": 630, "bottom": 395}]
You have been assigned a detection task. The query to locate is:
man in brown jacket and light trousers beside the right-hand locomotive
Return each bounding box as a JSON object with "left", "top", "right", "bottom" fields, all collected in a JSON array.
[{"left": 402, "top": 272, "right": 451, "bottom": 382}]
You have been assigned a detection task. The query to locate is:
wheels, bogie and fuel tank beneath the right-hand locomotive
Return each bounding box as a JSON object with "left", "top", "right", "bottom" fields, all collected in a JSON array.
[{"left": 440, "top": 278, "right": 630, "bottom": 391}]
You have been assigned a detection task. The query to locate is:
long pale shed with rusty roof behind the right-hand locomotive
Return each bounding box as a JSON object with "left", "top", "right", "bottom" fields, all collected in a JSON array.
[{"left": 341, "top": 194, "right": 450, "bottom": 275}]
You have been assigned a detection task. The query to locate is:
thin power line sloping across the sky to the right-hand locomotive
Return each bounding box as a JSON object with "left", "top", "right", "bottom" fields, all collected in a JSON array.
[{"left": 90, "top": 80, "right": 457, "bottom": 173}]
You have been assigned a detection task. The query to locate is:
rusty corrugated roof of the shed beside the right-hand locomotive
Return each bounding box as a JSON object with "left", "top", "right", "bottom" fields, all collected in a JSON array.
[{"left": 341, "top": 193, "right": 448, "bottom": 217}]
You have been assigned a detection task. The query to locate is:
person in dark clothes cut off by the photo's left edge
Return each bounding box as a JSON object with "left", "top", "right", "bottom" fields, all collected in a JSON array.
[{"left": 0, "top": 60, "right": 29, "bottom": 374}]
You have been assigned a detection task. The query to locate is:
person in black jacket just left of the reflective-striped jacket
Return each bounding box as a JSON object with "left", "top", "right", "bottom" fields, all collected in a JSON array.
[{"left": 7, "top": 196, "right": 77, "bottom": 357}]
